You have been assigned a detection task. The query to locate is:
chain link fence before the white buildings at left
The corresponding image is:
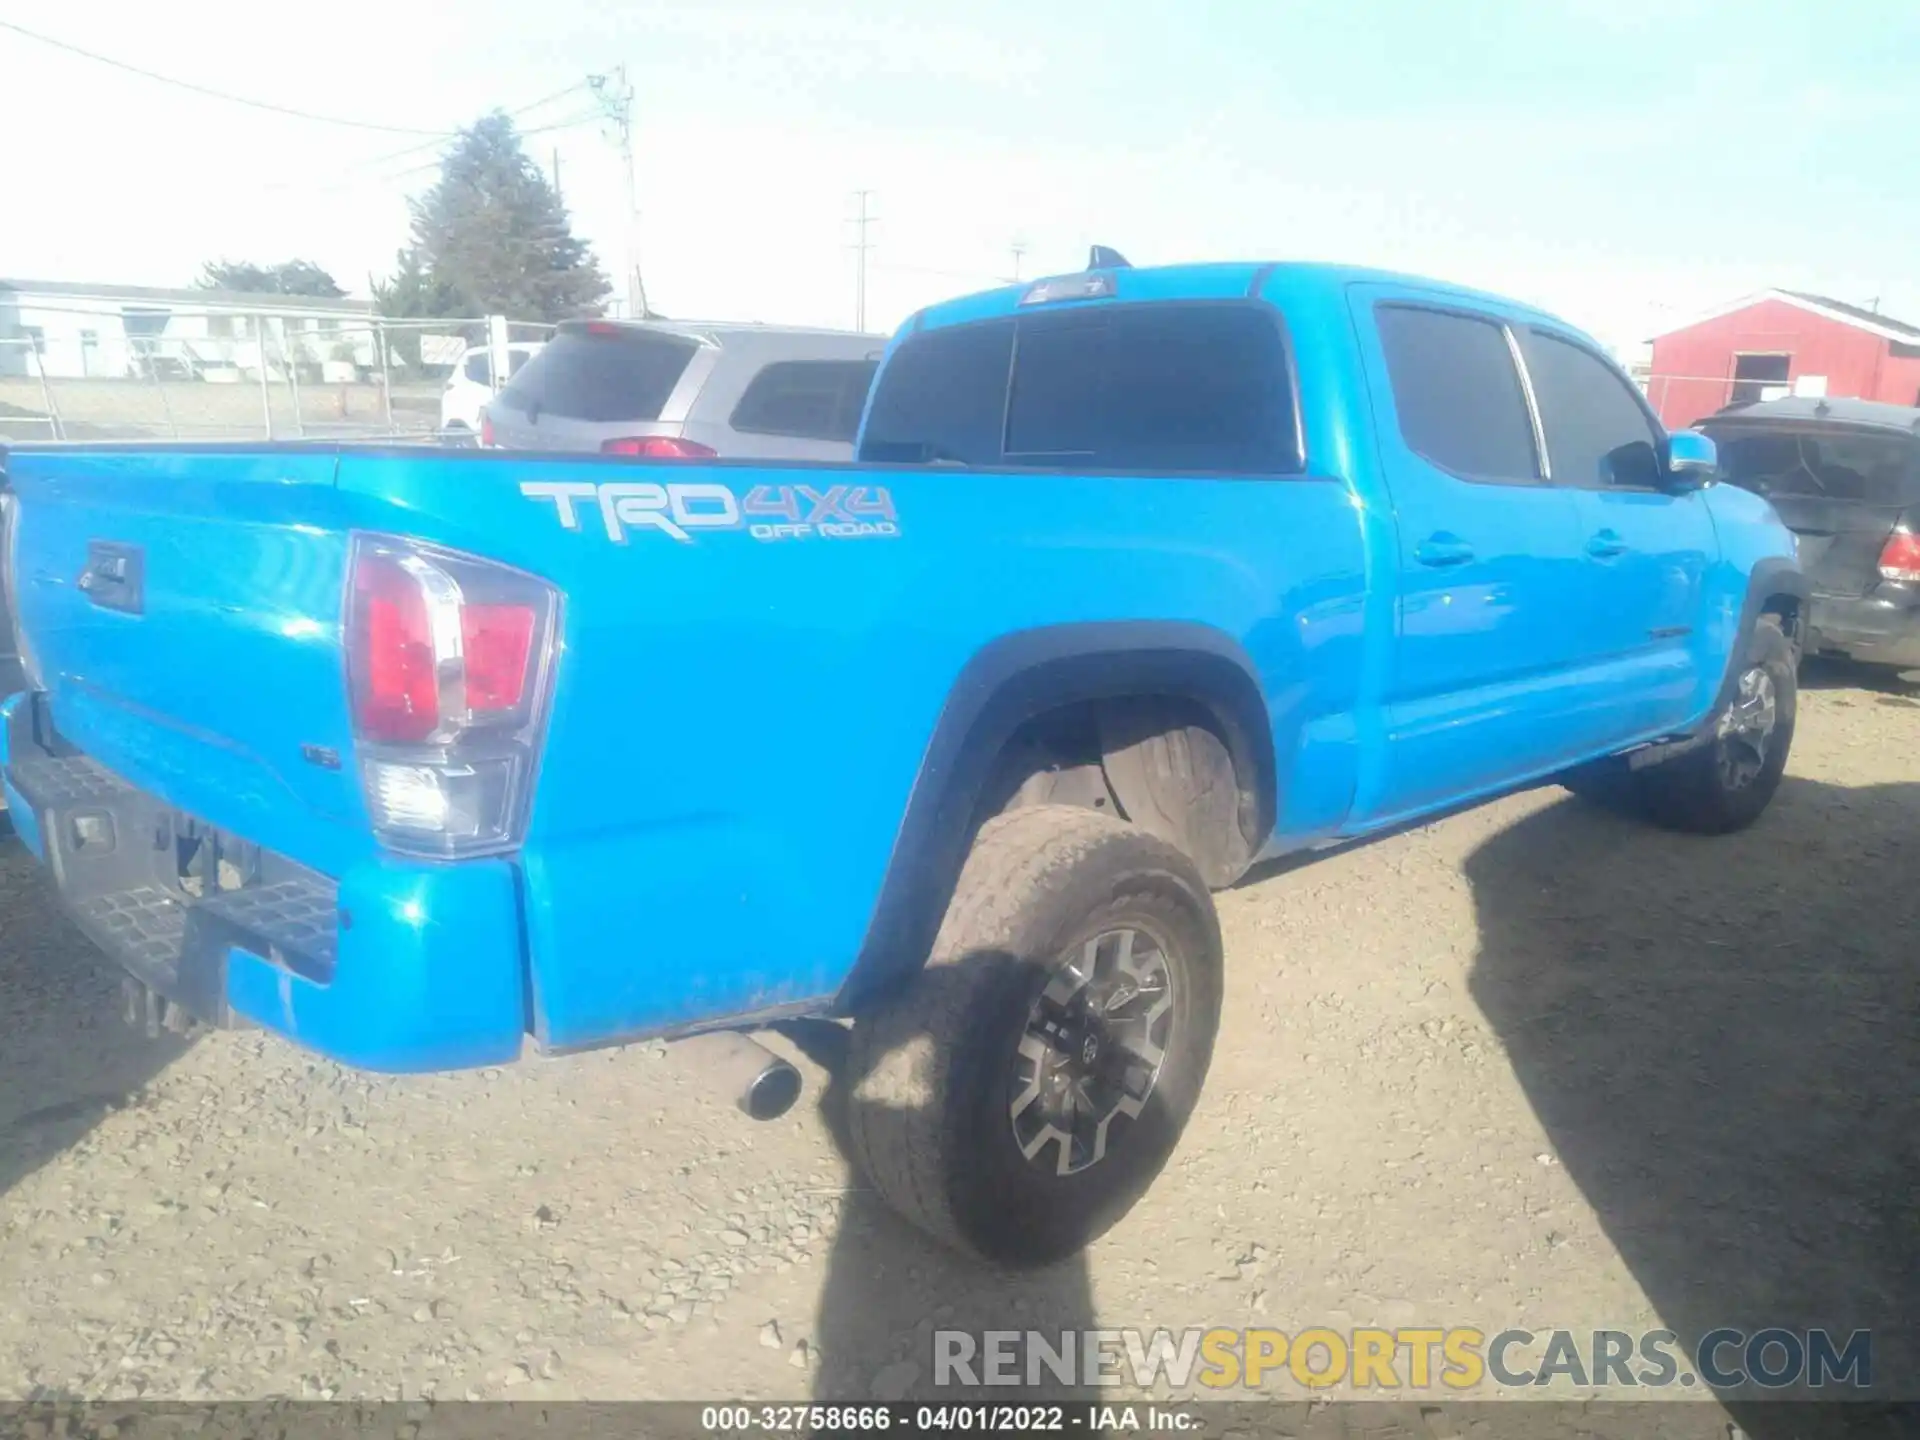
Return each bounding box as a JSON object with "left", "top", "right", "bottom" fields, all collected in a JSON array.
[{"left": 0, "top": 303, "right": 553, "bottom": 444}]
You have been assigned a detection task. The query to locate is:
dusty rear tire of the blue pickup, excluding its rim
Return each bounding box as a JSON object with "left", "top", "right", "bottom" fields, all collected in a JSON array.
[{"left": 847, "top": 804, "right": 1221, "bottom": 1267}]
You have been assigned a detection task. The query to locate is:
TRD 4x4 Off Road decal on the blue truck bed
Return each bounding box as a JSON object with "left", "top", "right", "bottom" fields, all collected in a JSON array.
[{"left": 520, "top": 480, "right": 900, "bottom": 545}]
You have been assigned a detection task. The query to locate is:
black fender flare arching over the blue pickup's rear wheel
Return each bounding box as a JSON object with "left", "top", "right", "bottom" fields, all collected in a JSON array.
[{"left": 835, "top": 620, "right": 1279, "bottom": 1014}]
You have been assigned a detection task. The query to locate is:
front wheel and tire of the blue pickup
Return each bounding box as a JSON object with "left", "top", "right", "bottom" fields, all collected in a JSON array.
[{"left": 1561, "top": 614, "right": 1799, "bottom": 835}]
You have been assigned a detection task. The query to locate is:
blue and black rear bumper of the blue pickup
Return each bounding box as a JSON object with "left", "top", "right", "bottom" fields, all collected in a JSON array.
[{"left": 0, "top": 695, "right": 526, "bottom": 1071}]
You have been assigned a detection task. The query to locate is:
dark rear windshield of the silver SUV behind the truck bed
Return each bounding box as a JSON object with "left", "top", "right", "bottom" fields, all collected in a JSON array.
[{"left": 501, "top": 323, "right": 699, "bottom": 422}]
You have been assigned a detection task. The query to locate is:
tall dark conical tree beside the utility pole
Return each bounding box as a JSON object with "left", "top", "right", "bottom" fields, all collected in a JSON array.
[{"left": 374, "top": 111, "right": 612, "bottom": 321}]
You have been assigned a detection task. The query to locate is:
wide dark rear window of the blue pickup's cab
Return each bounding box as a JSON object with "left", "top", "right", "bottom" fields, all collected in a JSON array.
[{"left": 860, "top": 301, "right": 1302, "bottom": 474}]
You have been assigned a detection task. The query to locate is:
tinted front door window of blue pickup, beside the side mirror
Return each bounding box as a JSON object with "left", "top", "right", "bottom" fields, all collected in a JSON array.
[{"left": 1521, "top": 330, "right": 1661, "bottom": 490}]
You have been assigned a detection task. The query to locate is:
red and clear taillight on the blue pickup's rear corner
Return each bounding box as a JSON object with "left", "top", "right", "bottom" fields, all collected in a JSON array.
[{"left": 342, "top": 534, "right": 561, "bottom": 858}]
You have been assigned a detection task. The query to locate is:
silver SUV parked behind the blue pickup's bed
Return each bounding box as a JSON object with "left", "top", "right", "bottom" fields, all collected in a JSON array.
[{"left": 482, "top": 321, "right": 885, "bottom": 461}]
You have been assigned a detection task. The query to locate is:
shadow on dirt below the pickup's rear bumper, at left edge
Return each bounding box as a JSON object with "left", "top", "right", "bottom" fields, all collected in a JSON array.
[{"left": 0, "top": 829, "right": 190, "bottom": 1194}]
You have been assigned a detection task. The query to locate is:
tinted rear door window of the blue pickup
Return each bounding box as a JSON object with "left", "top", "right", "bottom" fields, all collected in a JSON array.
[{"left": 1375, "top": 305, "right": 1540, "bottom": 486}]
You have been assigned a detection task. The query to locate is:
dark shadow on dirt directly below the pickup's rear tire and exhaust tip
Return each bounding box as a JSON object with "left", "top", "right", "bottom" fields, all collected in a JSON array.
[{"left": 785, "top": 990, "right": 1100, "bottom": 1404}]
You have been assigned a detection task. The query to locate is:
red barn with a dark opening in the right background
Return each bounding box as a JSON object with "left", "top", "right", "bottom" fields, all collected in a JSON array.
[{"left": 1647, "top": 290, "right": 1920, "bottom": 430}]
